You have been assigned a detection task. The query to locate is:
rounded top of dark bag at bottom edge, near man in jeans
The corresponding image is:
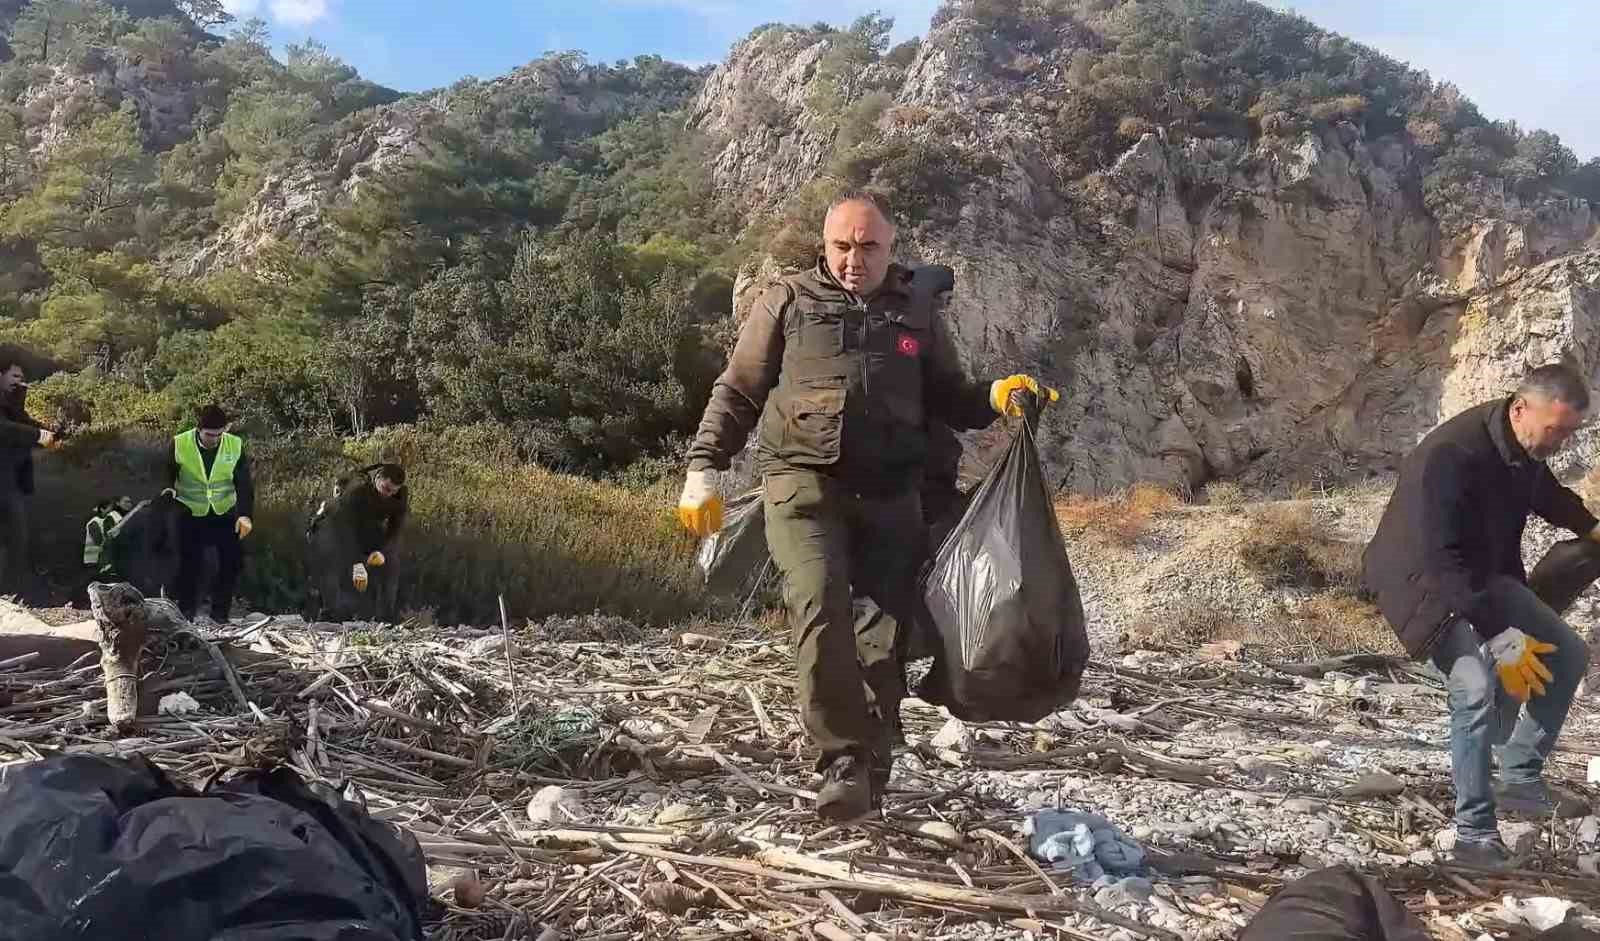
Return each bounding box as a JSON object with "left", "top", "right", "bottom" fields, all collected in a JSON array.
[{"left": 1238, "top": 866, "right": 1429, "bottom": 941}]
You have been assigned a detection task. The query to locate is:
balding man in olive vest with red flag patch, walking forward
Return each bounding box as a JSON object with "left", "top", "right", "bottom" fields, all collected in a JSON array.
[{"left": 678, "top": 192, "right": 1056, "bottom": 819}]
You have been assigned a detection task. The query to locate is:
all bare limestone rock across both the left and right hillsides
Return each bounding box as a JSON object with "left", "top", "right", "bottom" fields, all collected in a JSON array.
[{"left": 21, "top": 16, "right": 1580, "bottom": 493}]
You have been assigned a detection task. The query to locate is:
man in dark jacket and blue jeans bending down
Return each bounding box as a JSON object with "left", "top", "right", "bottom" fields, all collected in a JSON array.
[{"left": 1362, "top": 365, "right": 1600, "bottom": 866}]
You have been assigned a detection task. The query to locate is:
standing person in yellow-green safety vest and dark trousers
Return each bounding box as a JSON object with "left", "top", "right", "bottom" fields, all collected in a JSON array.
[{"left": 165, "top": 405, "right": 256, "bottom": 624}]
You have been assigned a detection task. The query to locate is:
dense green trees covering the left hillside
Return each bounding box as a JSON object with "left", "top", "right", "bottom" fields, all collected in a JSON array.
[{"left": 0, "top": 0, "right": 731, "bottom": 474}]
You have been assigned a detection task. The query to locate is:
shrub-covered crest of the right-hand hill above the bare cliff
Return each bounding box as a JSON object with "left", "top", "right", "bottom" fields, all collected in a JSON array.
[{"left": 934, "top": 0, "right": 1600, "bottom": 229}]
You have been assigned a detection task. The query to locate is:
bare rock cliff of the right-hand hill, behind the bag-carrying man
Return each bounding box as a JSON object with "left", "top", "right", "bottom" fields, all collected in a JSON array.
[{"left": 693, "top": 16, "right": 1600, "bottom": 491}]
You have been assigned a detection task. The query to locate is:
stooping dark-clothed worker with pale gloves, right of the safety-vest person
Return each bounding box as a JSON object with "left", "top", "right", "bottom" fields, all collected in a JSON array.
[{"left": 306, "top": 464, "right": 410, "bottom": 621}]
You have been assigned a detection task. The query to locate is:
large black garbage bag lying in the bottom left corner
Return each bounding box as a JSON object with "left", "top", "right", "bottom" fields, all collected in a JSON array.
[{"left": 0, "top": 755, "right": 427, "bottom": 941}]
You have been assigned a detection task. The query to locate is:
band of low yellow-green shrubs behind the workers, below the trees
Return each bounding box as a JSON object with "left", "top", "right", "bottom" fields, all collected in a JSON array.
[{"left": 30, "top": 426, "right": 706, "bottom": 624}]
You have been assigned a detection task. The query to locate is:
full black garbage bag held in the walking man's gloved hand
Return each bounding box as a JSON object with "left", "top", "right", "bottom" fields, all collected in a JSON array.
[{"left": 918, "top": 414, "right": 1090, "bottom": 722}]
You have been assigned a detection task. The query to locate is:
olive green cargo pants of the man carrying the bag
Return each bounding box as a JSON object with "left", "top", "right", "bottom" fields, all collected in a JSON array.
[{"left": 765, "top": 471, "right": 926, "bottom": 763}]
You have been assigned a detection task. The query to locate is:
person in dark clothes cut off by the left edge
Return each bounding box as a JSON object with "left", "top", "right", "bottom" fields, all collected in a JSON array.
[{"left": 0, "top": 355, "right": 56, "bottom": 597}]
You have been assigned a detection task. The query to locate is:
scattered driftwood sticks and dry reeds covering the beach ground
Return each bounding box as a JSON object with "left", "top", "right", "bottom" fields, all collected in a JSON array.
[{"left": 0, "top": 586, "right": 1600, "bottom": 941}]
